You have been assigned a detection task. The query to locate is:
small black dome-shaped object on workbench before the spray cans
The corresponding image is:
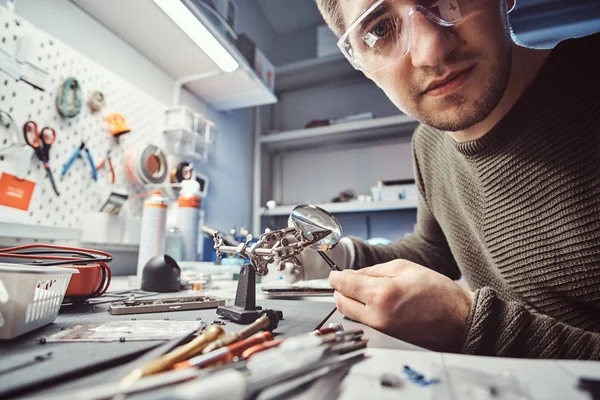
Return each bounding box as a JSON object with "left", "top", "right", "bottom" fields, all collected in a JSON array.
[{"left": 142, "top": 255, "right": 181, "bottom": 292}]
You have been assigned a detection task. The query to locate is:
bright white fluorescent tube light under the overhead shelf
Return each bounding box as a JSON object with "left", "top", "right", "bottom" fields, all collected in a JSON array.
[{"left": 154, "top": 0, "right": 240, "bottom": 72}]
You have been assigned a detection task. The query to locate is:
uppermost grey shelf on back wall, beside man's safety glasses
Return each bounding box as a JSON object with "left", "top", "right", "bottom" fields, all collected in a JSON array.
[{"left": 275, "top": 53, "right": 367, "bottom": 93}]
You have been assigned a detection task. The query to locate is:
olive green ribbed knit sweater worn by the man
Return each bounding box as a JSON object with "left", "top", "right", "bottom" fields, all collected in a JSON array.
[{"left": 354, "top": 34, "right": 600, "bottom": 360}]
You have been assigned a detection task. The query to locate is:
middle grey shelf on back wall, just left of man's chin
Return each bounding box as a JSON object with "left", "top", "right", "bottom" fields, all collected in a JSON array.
[{"left": 260, "top": 115, "right": 418, "bottom": 151}]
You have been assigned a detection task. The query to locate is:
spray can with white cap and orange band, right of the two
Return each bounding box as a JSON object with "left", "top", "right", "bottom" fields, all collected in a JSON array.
[{"left": 177, "top": 179, "right": 201, "bottom": 261}]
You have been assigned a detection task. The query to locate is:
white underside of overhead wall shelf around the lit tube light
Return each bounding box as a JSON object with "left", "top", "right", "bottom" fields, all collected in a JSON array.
[{"left": 72, "top": 0, "right": 277, "bottom": 111}]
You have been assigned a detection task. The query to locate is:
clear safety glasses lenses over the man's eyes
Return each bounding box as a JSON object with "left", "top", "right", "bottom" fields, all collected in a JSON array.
[{"left": 338, "top": 0, "right": 488, "bottom": 72}]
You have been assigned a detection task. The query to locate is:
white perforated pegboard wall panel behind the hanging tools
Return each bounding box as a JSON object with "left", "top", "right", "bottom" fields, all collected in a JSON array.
[{"left": 0, "top": 7, "right": 167, "bottom": 228}]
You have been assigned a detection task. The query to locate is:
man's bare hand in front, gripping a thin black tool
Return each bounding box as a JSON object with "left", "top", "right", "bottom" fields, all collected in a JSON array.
[{"left": 329, "top": 260, "right": 473, "bottom": 352}]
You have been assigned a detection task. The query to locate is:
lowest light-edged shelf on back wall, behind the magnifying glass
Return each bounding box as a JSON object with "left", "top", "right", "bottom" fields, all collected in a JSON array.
[{"left": 260, "top": 200, "right": 417, "bottom": 217}]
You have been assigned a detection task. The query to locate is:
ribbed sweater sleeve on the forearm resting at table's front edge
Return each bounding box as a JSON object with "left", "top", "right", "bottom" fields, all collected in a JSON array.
[{"left": 462, "top": 287, "right": 600, "bottom": 360}]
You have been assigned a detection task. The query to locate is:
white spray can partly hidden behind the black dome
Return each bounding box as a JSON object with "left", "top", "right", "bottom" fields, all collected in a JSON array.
[{"left": 137, "top": 190, "right": 167, "bottom": 280}]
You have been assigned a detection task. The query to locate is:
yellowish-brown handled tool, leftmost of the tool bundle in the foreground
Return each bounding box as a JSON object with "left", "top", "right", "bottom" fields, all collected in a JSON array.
[{"left": 119, "top": 325, "right": 225, "bottom": 388}]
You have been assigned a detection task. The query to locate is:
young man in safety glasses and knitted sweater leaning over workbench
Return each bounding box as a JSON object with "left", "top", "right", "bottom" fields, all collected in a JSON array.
[{"left": 288, "top": 0, "right": 600, "bottom": 360}]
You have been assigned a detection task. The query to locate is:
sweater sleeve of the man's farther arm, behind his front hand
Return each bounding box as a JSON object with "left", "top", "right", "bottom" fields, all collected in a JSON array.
[{"left": 351, "top": 195, "right": 461, "bottom": 280}]
